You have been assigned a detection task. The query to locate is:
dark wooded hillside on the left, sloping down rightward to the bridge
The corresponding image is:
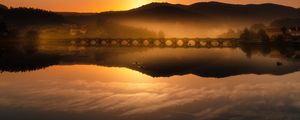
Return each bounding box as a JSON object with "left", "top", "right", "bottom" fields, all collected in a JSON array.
[{"left": 0, "top": 5, "right": 164, "bottom": 41}]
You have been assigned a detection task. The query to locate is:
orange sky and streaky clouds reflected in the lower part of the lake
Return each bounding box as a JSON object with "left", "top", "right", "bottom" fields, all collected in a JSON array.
[{"left": 0, "top": 65, "right": 300, "bottom": 120}]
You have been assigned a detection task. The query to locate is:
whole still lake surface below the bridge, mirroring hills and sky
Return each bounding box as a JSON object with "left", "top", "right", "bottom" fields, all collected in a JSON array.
[{"left": 0, "top": 43, "right": 300, "bottom": 120}]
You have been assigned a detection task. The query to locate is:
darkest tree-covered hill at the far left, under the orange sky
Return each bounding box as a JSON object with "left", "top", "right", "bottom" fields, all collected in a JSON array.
[{"left": 0, "top": 4, "right": 66, "bottom": 41}]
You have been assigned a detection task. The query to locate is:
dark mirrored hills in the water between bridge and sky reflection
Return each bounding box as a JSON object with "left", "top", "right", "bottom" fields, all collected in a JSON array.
[{"left": 0, "top": 41, "right": 300, "bottom": 77}]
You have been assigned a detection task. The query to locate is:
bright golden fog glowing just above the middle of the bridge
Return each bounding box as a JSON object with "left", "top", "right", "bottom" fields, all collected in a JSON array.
[{"left": 120, "top": 20, "right": 252, "bottom": 38}]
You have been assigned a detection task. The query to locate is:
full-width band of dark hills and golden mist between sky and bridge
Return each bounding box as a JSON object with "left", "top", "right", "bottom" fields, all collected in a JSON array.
[{"left": 0, "top": 2, "right": 300, "bottom": 40}]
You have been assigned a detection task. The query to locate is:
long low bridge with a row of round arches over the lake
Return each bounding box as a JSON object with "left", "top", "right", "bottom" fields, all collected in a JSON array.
[{"left": 70, "top": 38, "right": 239, "bottom": 48}]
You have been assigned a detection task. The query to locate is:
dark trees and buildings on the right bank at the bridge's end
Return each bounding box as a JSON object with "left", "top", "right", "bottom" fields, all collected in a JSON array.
[{"left": 238, "top": 18, "right": 300, "bottom": 44}]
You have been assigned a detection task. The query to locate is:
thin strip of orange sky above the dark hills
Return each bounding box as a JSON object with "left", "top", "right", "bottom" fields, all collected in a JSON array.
[{"left": 0, "top": 0, "right": 300, "bottom": 12}]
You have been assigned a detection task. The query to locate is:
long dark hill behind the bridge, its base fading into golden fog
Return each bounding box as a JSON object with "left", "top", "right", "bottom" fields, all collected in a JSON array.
[{"left": 92, "top": 2, "right": 300, "bottom": 37}]
